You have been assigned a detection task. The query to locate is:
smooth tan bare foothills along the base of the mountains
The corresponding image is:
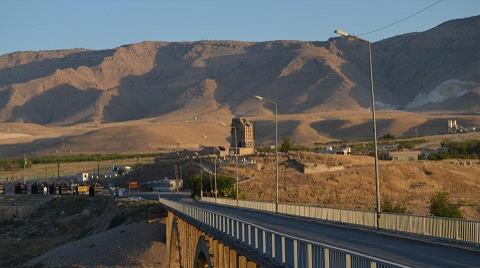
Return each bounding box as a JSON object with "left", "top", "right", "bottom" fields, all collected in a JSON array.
[{"left": 0, "top": 111, "right": 480, "bottom": 157}]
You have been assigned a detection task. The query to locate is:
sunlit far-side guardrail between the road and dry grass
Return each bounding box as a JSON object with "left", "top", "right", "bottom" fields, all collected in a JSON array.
[{"left": 202, "top": 197, "right": 480, "bottom": 244}]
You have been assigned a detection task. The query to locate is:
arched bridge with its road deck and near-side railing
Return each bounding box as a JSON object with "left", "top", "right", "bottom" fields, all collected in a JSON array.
[{"left": 159, "top": 194, "right": 480, "bottom": 268}]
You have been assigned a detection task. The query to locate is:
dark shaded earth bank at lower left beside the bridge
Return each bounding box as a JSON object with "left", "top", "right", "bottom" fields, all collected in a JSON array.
[{"left": 0, "top": 196, "right": 168, "bottom": 267}]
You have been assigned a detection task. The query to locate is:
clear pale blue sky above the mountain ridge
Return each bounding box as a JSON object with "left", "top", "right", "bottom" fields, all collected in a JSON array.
[{"left": 0, "top": 0, "right": 480, "bottom": 55}]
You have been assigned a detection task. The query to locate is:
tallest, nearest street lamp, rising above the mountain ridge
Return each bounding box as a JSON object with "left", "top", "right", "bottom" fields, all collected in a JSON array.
[{"left": 335, "top": 29, "right": 382, "bottom": 228}]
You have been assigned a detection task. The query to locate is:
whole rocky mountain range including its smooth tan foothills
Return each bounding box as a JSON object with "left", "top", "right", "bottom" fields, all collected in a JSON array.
[{"left": 0, "top": 16, "right": 480, "bottom": 156}]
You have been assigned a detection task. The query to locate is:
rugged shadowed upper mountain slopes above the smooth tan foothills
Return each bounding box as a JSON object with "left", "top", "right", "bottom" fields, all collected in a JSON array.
[{"left": 0, "top": 16, "right": 480, "bottom": 125}]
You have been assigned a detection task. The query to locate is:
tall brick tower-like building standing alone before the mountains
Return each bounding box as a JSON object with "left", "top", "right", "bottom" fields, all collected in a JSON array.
[{"left": 230, "top": 117, "right": 255, "bottom": 155}]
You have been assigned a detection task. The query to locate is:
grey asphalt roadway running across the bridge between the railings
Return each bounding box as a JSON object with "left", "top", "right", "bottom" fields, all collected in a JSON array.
[{"left": 140, "top": 193, "right": 480, "bottom": 267}]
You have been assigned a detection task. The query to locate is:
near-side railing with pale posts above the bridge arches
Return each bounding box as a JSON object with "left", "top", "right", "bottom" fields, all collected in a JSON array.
[{"left": 159, "top": 198, "right": 408, "bottom": 268}]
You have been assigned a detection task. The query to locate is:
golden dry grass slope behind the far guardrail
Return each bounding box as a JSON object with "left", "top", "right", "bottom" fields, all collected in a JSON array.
[{"left": 225, "top": 153, "right": 480, "bottom": 219}]
